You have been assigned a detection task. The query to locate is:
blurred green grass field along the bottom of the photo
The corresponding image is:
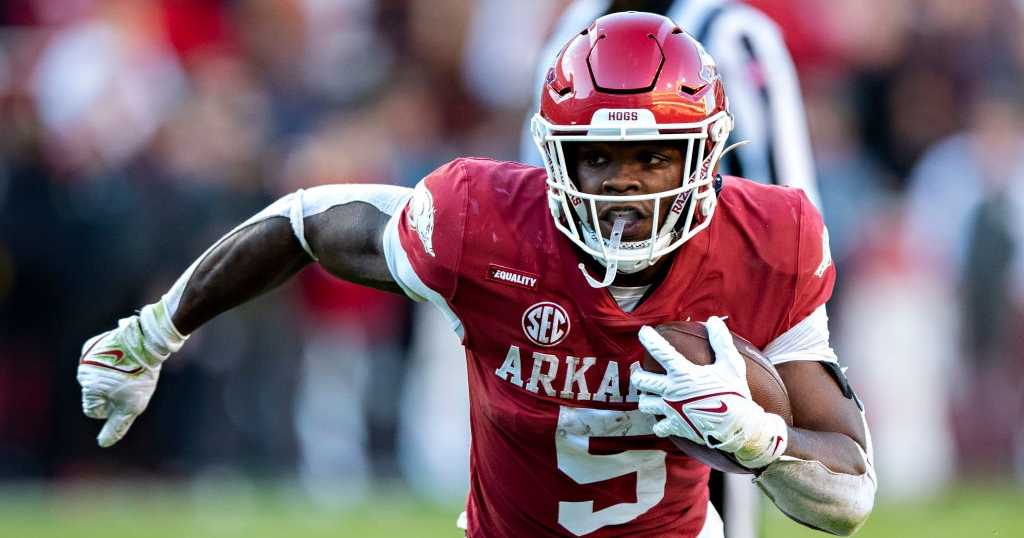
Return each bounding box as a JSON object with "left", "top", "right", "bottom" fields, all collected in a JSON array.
[{"left": 0, "top": 475, "right": 1024, "bottom": 538}]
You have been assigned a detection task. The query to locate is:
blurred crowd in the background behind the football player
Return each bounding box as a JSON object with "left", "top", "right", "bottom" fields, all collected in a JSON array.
[{"left": 0, "top": 0, "right": 1024, "bottom": 506}]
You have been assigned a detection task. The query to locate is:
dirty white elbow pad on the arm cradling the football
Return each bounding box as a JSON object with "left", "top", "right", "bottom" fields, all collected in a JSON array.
[{"left": 754, "top": 456, "right": 877, "bottom": 536}]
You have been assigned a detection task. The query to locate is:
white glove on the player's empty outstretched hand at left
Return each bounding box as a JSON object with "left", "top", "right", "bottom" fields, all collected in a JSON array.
[{"left": 78, "top": 300, "right": 187, "bottom": 447}]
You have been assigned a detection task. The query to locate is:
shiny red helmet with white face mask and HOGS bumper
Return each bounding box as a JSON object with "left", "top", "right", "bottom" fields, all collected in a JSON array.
[{"left": 531, "top": 11, "right": 732, "bottom": 286}]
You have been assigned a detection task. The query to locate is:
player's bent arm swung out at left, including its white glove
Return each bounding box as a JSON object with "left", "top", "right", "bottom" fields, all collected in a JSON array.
[{"left": 78, "top": 185, "right": 410, "bottom": 447}]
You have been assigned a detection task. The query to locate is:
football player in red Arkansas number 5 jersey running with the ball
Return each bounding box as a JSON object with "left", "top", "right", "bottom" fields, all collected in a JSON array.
[{"left": 78, "top": 12, "right": 876, "bottom": 537}]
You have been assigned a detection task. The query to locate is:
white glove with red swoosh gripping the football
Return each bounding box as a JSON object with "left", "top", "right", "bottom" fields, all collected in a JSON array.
[{"left": 630, "top": 317, "right": 788, "bottom": 469}]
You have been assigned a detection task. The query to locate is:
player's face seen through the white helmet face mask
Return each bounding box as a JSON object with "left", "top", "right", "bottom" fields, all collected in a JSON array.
[{"left": 575, "top": 141, "right": 684, "bottom": 241}]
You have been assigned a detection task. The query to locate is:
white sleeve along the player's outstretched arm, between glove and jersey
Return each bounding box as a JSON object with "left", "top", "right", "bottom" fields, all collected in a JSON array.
[{"left": 163, "top": 183, "right": 413, "bottom": 317}]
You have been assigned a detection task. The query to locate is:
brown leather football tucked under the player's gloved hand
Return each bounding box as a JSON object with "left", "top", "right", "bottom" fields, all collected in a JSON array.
[{"left": 641, "top": 321, "right": 793, "bottom": 473}]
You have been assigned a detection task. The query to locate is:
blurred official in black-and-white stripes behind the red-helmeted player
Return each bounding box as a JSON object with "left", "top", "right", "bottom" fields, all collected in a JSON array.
[{"left": 487, "top": 0, "right": 827, "bottom": 538}]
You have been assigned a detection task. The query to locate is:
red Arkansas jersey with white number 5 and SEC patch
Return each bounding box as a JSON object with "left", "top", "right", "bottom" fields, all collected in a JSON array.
[{"left": 398, "top": 159, "right": 835, "bottom": 538}]
